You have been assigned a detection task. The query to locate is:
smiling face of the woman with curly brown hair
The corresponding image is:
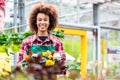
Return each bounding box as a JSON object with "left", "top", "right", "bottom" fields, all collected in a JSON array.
[{"left": 36, "top": 13, "right": 50, "bottom": 33}]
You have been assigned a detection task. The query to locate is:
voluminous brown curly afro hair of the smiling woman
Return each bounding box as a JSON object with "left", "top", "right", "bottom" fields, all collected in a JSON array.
[{"left": 29, "top": 3, "right": 58, "bottom": 33}]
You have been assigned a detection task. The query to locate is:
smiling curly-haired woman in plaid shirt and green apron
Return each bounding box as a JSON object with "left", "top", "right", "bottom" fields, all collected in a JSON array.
[{"left": 19, "top": 4, "right": 66, "bottom": 80}]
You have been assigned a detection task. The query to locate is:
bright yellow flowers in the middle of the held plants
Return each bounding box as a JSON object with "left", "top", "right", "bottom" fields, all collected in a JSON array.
[{"left": 42, "top": 51, "right": 54, "bottom": 66}]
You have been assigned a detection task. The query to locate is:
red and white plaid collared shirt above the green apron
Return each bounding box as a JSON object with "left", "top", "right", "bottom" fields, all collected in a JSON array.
[{"left": 18, "top": 35, "right": 64, "bottom": 62}]
